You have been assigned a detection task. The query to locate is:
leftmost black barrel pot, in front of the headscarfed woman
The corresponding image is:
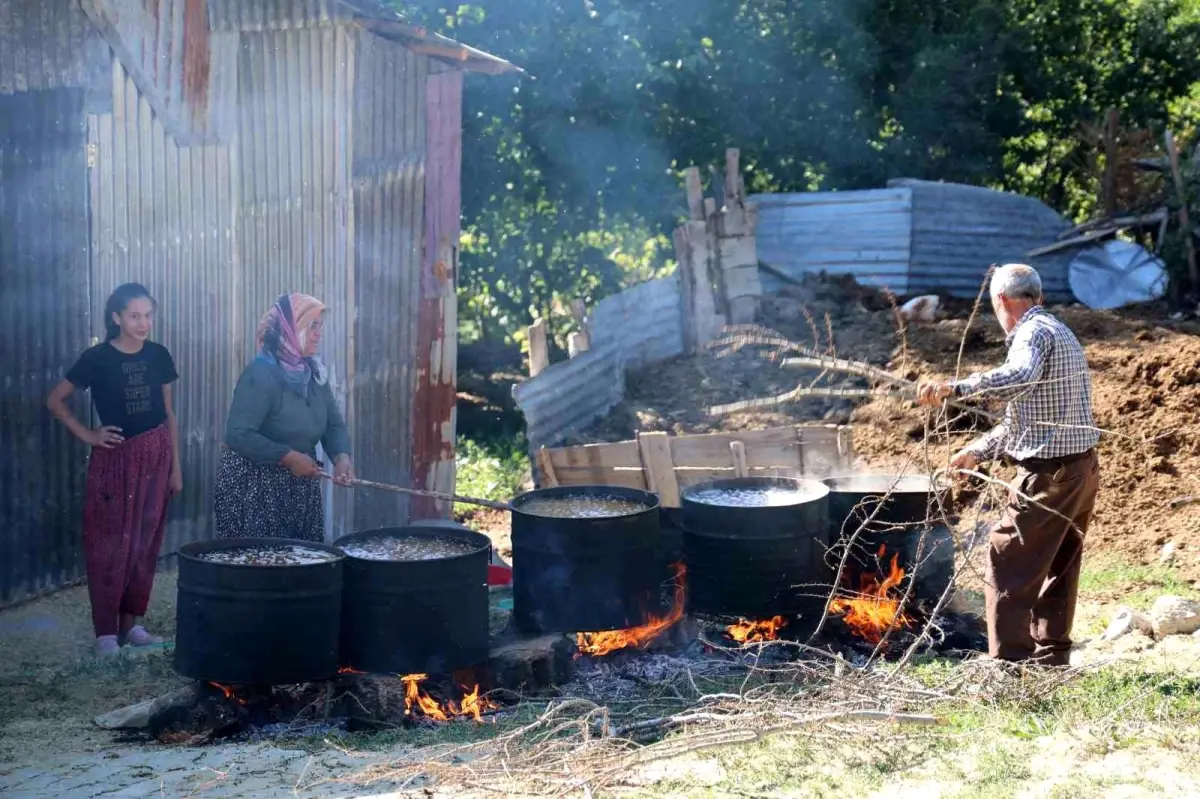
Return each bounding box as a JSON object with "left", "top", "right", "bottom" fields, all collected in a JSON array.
[{"left": 175, "top": 539, "right": 346, "bottom": 685}]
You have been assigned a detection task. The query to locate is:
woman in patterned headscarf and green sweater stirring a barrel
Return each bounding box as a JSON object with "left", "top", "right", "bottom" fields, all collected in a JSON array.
[{"left": 214, "top": 294, "right": 354, "bottom": 541}]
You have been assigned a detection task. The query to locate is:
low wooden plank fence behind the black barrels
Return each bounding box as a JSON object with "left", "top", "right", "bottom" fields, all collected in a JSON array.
[{"left": 536, "top": 425, "right": 854, "bottom": 507}]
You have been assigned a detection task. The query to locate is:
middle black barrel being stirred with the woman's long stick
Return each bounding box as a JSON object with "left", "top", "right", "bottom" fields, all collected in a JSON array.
[{"left": 512, "top": 486, "right": 664, "bottom": 632}]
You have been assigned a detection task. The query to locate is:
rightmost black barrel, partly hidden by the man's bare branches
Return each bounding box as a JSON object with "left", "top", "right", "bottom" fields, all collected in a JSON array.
[{"left": 823, "top": 474, "right": 954, "bottom": 600}]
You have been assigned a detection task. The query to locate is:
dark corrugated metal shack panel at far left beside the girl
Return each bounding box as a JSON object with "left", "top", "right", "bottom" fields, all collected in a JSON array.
[{"left": 0, "top": 89, "right": 90, "bottom": 605}]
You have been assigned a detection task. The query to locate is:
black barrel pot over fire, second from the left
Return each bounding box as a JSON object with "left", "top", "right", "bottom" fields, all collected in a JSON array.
[{"left": 335, "top": 523, "right": 492, "bottom": 674}]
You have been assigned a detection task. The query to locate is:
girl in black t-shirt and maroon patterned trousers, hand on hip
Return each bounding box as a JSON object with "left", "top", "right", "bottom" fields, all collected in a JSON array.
[{"left": 47, "top": 283, "right": 184, "bottom": 655}]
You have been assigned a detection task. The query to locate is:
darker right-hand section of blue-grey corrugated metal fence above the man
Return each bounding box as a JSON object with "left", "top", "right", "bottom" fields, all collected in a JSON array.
[{"left": 888, "top": 180, "right": 1072, "bottom": 301}]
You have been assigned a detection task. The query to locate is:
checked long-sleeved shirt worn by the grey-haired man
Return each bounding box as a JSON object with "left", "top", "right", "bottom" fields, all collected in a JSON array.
[{"left": 950, "top": 306, "right": 1100, "bottom": 461}]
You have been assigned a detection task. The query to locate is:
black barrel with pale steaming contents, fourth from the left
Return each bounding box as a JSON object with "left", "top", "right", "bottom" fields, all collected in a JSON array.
[{"left": 680, "top": 477, "right": 830, "bottom": 623}]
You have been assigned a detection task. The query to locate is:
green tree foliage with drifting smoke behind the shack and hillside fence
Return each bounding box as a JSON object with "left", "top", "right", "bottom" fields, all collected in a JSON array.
[{"left": 396, "top": 0, "right": 1200, "bottom": 336}]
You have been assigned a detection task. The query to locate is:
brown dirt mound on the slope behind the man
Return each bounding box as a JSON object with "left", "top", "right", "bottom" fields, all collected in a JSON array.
[{"left": 580, "top": 273, "right": 1200, "bottom": 578}]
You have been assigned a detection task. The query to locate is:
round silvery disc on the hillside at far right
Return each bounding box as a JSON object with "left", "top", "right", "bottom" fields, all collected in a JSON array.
[{"left": 1067, "top": 239, "right": 1166, "bottom": 311}]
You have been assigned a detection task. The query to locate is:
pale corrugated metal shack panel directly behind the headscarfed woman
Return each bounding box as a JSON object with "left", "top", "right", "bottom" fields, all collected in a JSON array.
[{"left": 235, "top": 28, "right": 356, "bottom": 536}]
